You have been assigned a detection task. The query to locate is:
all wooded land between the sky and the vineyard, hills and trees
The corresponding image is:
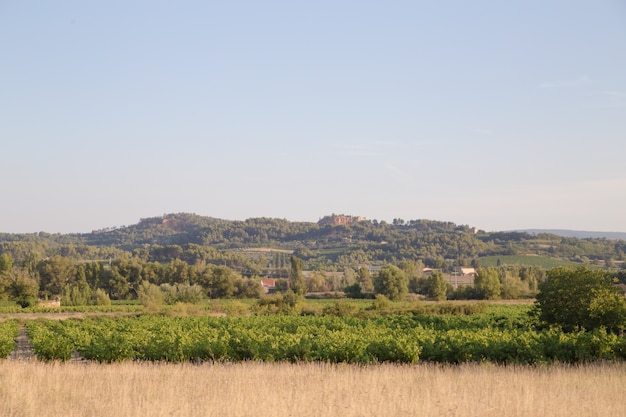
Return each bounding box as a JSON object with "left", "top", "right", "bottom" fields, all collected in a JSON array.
[{"left": 0, "top": 213, "right": 626, "bottom": 308}]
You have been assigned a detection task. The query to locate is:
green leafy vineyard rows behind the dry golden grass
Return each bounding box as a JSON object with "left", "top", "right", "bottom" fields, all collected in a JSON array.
[{"left": 13, "top": 306, "right": 626, "bottom": 364}]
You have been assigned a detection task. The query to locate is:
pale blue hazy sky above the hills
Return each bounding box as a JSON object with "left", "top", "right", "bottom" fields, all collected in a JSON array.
[{"left": 0, "top": 0, "right": 626, "bottom": 233}]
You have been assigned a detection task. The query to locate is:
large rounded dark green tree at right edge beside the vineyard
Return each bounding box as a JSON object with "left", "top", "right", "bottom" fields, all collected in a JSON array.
[{"left": 535, "top": 266, "right": 626, "bottom": 331}]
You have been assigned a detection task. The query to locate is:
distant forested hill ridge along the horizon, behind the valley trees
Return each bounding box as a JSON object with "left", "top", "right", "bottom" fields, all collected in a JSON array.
[{"left": 0, "top": 213, "right": 626, "bottom": 267}]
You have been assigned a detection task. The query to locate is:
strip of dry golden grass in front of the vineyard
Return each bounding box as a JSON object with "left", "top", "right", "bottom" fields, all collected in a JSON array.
[{"left": 0, "top": 360, "right": 626, "bottom": 417}]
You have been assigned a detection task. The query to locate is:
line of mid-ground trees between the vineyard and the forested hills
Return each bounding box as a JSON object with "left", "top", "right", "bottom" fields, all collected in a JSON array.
[{"left": 0, "top": 253, "right": 545, "bottom": 306}]
